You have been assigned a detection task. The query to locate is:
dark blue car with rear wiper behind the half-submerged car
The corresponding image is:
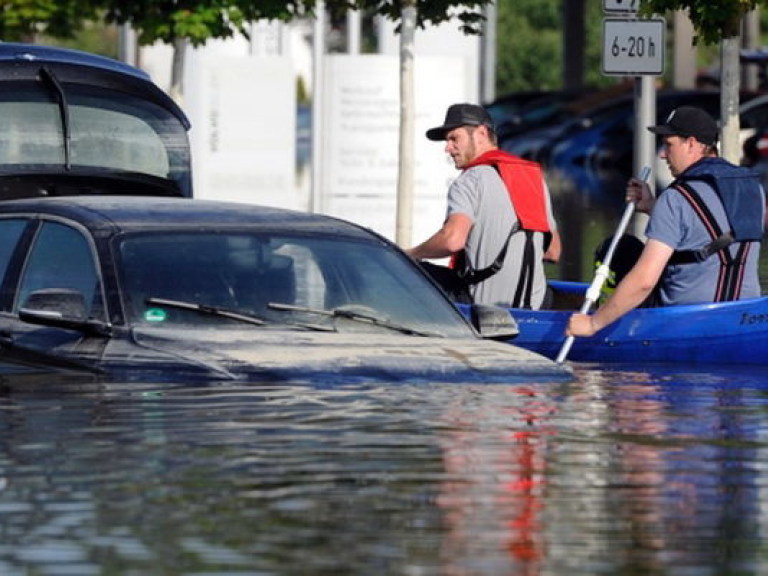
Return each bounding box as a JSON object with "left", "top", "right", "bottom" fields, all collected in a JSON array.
[{"left": 0, "top": 43, "right": 192, "bottom": 199}]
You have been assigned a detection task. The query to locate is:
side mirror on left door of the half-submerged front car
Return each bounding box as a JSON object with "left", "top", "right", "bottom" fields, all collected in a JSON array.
[{"left": 19, "top": 288, "right": 109, "bottom": 336}]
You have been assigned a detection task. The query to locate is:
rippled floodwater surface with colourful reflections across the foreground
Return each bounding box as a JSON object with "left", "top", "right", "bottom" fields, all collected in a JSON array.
[{"left": 0, "top": 365, "right": 768, "bottom": 576}]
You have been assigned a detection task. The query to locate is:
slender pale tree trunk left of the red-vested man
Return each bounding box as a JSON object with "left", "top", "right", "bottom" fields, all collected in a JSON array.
[{"left": 395, "top": 0, "right": 417, "bottom": 248}]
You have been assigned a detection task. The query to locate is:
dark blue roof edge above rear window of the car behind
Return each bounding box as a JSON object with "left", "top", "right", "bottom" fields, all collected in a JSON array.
[{"left": 0, "top": 42, "right": 190, "bottom": 130}]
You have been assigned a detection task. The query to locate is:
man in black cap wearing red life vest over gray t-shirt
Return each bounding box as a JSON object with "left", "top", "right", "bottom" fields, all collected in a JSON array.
[{"left": 408, "top": 104, "right": 560, "bottom": 309}]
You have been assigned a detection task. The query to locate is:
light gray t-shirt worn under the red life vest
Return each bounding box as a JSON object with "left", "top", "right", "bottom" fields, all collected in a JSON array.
[{"left": 447, "top": 166, "right": 556, "bottom": 309}]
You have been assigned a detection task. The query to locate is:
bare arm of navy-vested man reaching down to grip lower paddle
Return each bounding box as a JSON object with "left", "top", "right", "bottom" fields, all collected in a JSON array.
[{"left": 565, "top": 239, "right": 673, "bottom": 336}]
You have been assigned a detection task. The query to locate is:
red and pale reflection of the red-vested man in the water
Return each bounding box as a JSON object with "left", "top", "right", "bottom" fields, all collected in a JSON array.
[{"left": 438, "top": 386, "right": 558, "bottom": 575}]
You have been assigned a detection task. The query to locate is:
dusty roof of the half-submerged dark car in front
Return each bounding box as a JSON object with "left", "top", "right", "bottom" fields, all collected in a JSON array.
[{"left": 0, "top": 196, "right": 381, "bottom": 239}]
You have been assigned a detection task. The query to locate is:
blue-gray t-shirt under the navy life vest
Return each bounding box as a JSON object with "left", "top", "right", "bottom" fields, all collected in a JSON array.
[{"left": 646, "top": 181, "right": 764, "bottom": 306}]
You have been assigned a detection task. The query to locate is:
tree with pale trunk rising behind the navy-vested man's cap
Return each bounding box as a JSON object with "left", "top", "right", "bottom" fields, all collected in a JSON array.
[{"left": 640, "top": 0, "right": 764, "bottom": 163}]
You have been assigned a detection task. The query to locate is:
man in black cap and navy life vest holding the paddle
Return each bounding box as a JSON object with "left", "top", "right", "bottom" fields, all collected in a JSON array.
[{"left": 566, "top": 106, "right": 765, "bottom": 336}]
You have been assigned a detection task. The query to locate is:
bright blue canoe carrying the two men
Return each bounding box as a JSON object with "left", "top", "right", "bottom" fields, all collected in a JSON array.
[{"left": 458, "top": 281, "right": 768, "bottom": 365}]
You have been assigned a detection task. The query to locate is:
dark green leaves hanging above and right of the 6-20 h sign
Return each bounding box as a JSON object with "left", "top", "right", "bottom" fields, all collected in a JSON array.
[{"left": 640, "top": 0, "right": 765, "bottom": 45}]
